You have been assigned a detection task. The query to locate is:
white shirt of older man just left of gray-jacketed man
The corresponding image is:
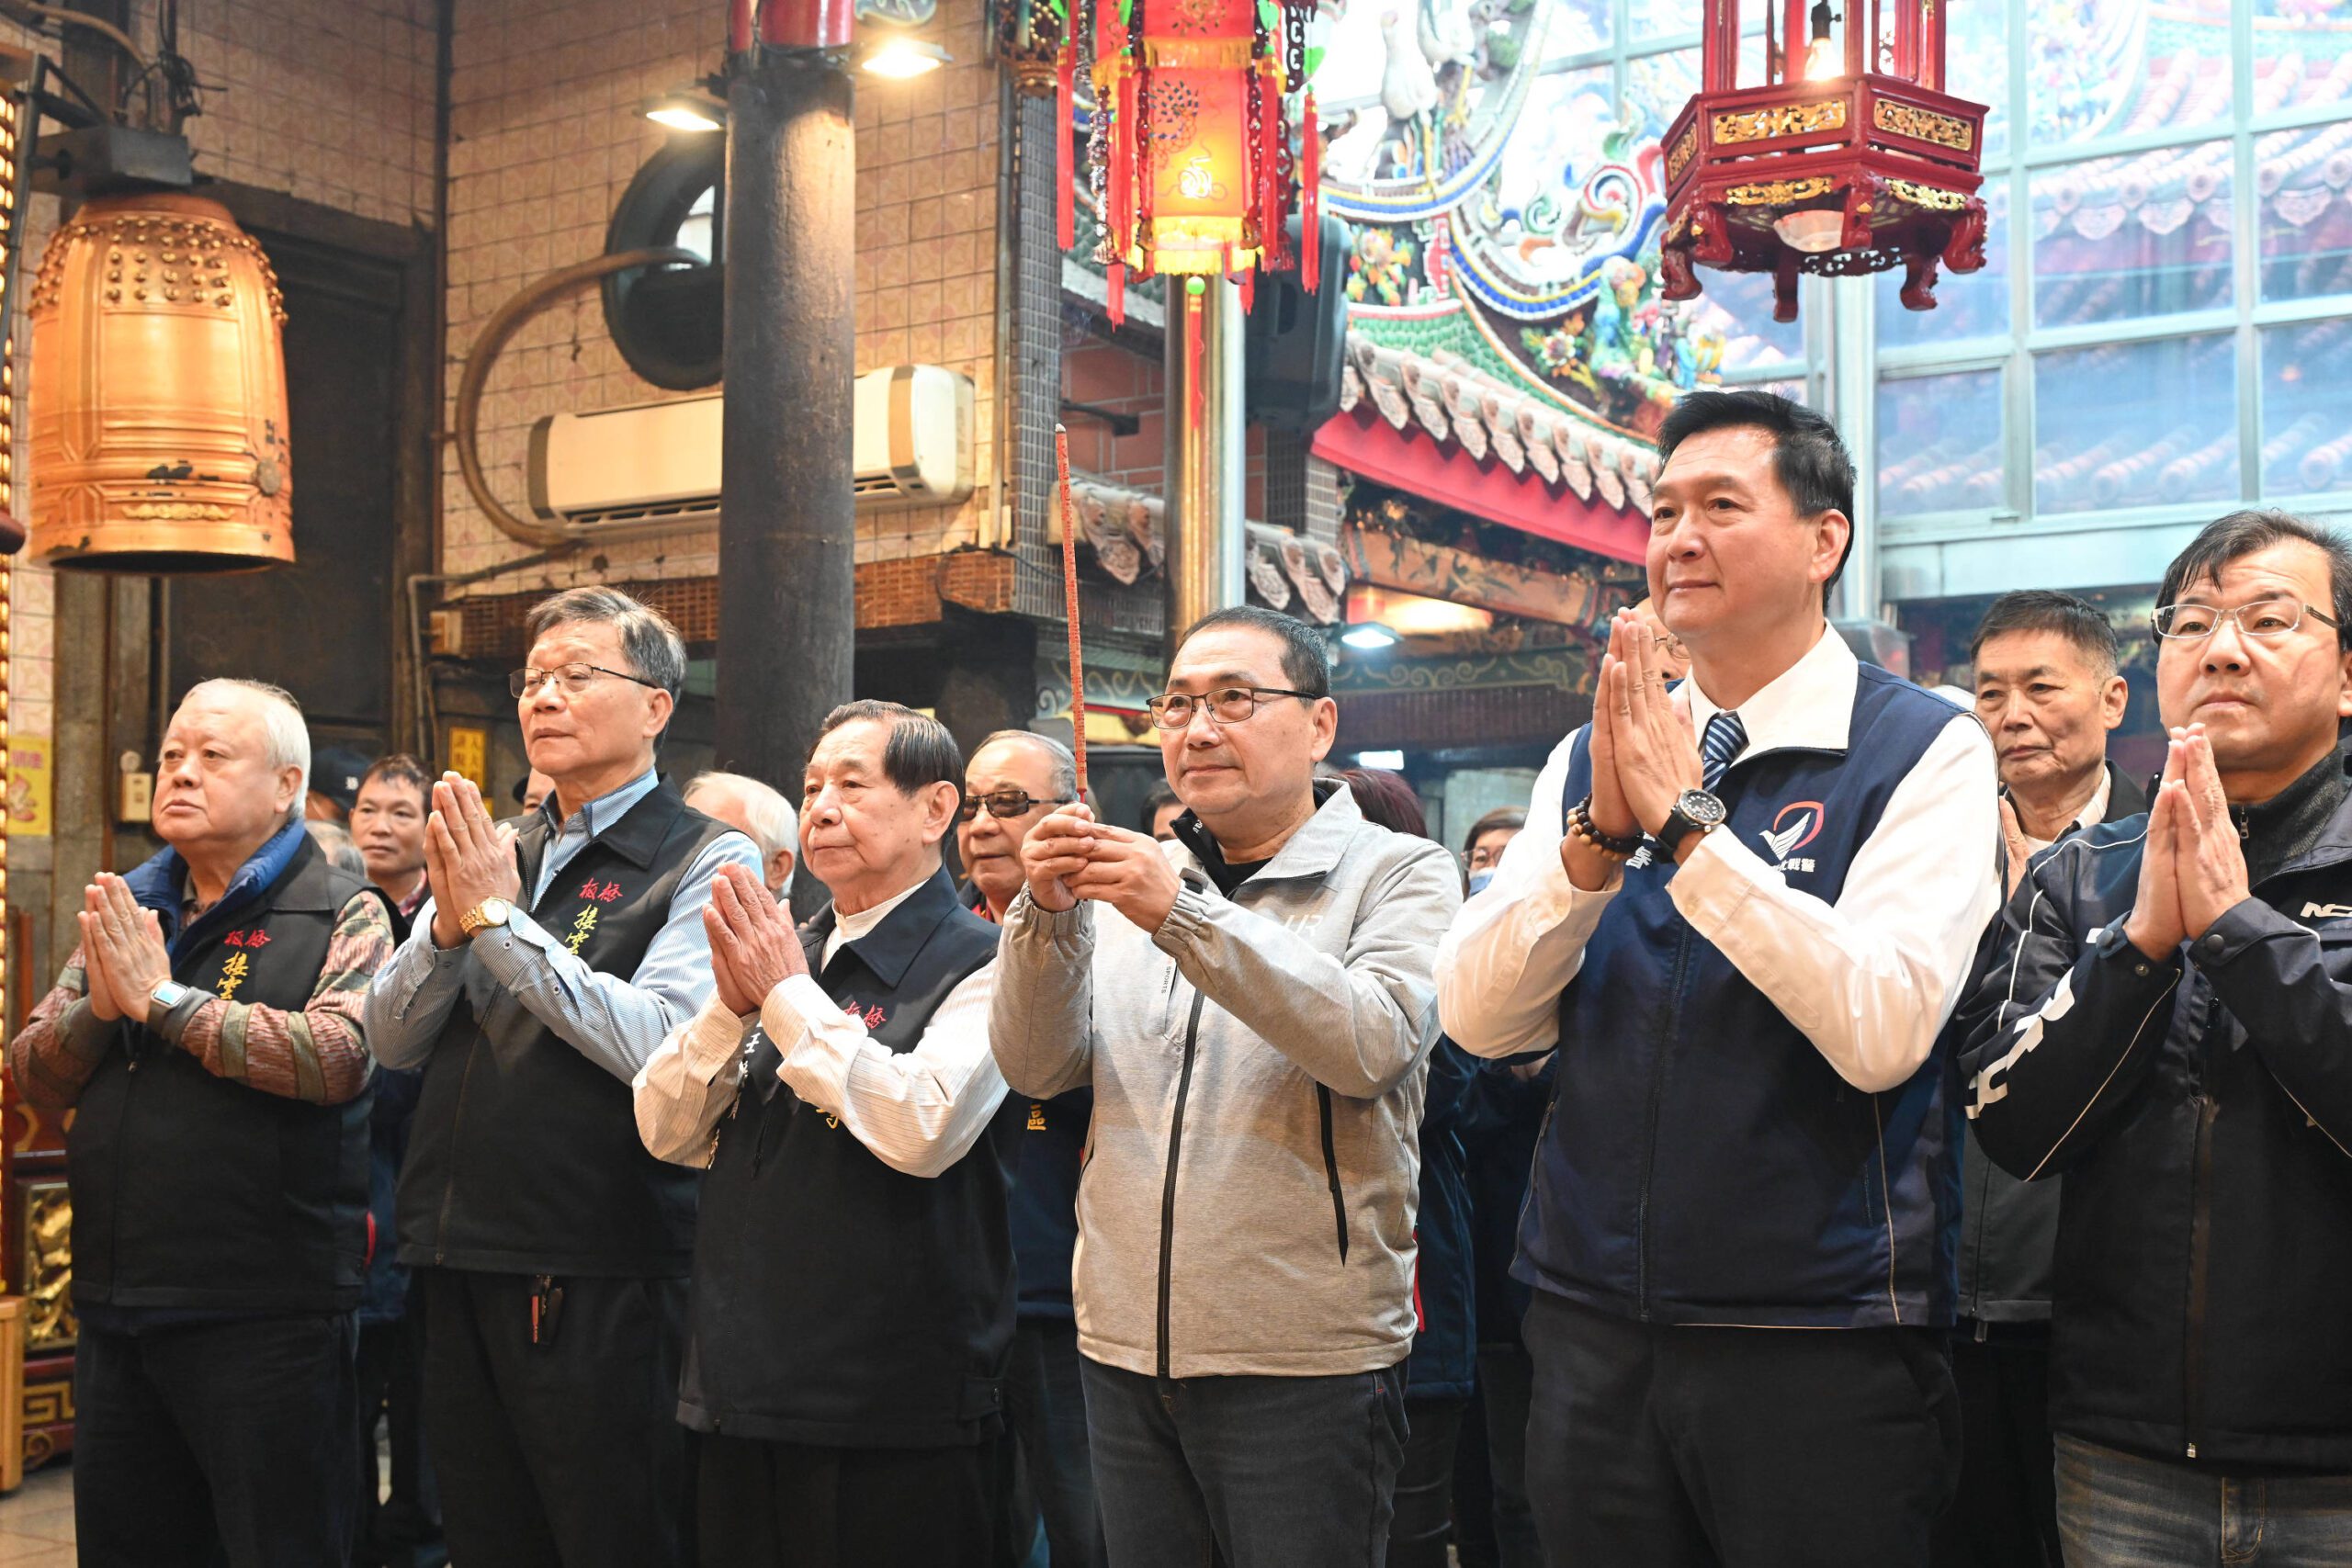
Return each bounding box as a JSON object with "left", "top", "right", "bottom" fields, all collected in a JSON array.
[{"left": 633, "top": 877, "right": 1004, "bottom": 1176}]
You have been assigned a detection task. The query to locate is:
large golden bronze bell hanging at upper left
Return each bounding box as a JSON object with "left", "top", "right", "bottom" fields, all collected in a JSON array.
[{"left": 30, "top": 190, "right": 294, "bottom": 573}]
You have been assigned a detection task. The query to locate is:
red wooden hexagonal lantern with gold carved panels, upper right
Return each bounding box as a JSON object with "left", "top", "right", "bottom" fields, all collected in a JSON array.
[{"left": 1660, "top": 0, "right": 1990, "bottom": 322}]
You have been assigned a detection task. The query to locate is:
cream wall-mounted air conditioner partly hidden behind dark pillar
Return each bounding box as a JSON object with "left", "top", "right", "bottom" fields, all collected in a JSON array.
[{"left": 532, "top": 365, "right": 974, "bottom": 526}]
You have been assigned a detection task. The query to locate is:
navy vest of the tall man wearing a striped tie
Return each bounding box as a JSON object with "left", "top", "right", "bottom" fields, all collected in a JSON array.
[{"left": 1512, "top": 665, "right": 1990, "bottom": 1328}]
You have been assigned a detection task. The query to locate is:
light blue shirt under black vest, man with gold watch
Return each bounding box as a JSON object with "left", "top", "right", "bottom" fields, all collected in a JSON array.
[{"left": 367, "top": 769, "right": 760, "bottom": 1084}]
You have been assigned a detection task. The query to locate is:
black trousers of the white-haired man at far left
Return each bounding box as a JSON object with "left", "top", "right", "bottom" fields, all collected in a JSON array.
[{"left": 73, "top": 1312, "right": 360, "bottom": 1568}]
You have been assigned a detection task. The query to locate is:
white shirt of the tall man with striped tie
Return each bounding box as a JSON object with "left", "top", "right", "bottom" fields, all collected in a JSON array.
[{"left": 1437, "top": 627, "right": 2002, "bottom": 1093}]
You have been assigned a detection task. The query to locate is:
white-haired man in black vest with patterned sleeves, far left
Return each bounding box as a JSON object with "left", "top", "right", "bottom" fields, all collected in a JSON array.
[{"left": 7, "top": 680, "right": 393, "bottom": 1568}]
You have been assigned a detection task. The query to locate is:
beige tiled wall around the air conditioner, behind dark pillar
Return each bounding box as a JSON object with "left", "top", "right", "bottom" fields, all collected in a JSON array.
[{"left": 442, "top": 0, "right": 997, "bottom": 594}]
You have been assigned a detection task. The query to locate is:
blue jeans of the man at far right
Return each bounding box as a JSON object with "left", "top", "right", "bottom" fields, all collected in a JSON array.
[{"left": 2058, "top": 1432, "right": 2352, "bottom": 1568}]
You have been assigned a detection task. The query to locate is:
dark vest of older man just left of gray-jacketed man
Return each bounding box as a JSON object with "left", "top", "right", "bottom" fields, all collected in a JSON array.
[{"left": 677, "top": 870, "right": 1013, "bottom": 1448}]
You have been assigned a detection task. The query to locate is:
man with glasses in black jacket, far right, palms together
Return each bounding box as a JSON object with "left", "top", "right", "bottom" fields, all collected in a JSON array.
[{"left": 1962, "top": 513, "right": 2352, "bottom": 1568}]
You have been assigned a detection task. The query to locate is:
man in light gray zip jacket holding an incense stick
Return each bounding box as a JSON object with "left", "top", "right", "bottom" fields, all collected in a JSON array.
[{"left": 990, "top": 609, "right": 1461, "bottom": 1568}]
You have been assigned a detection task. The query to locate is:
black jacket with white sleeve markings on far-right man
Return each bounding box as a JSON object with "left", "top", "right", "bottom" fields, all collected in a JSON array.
[{"left": 1964, "top": 757, "right": 2352, "bottom": 1474}]
